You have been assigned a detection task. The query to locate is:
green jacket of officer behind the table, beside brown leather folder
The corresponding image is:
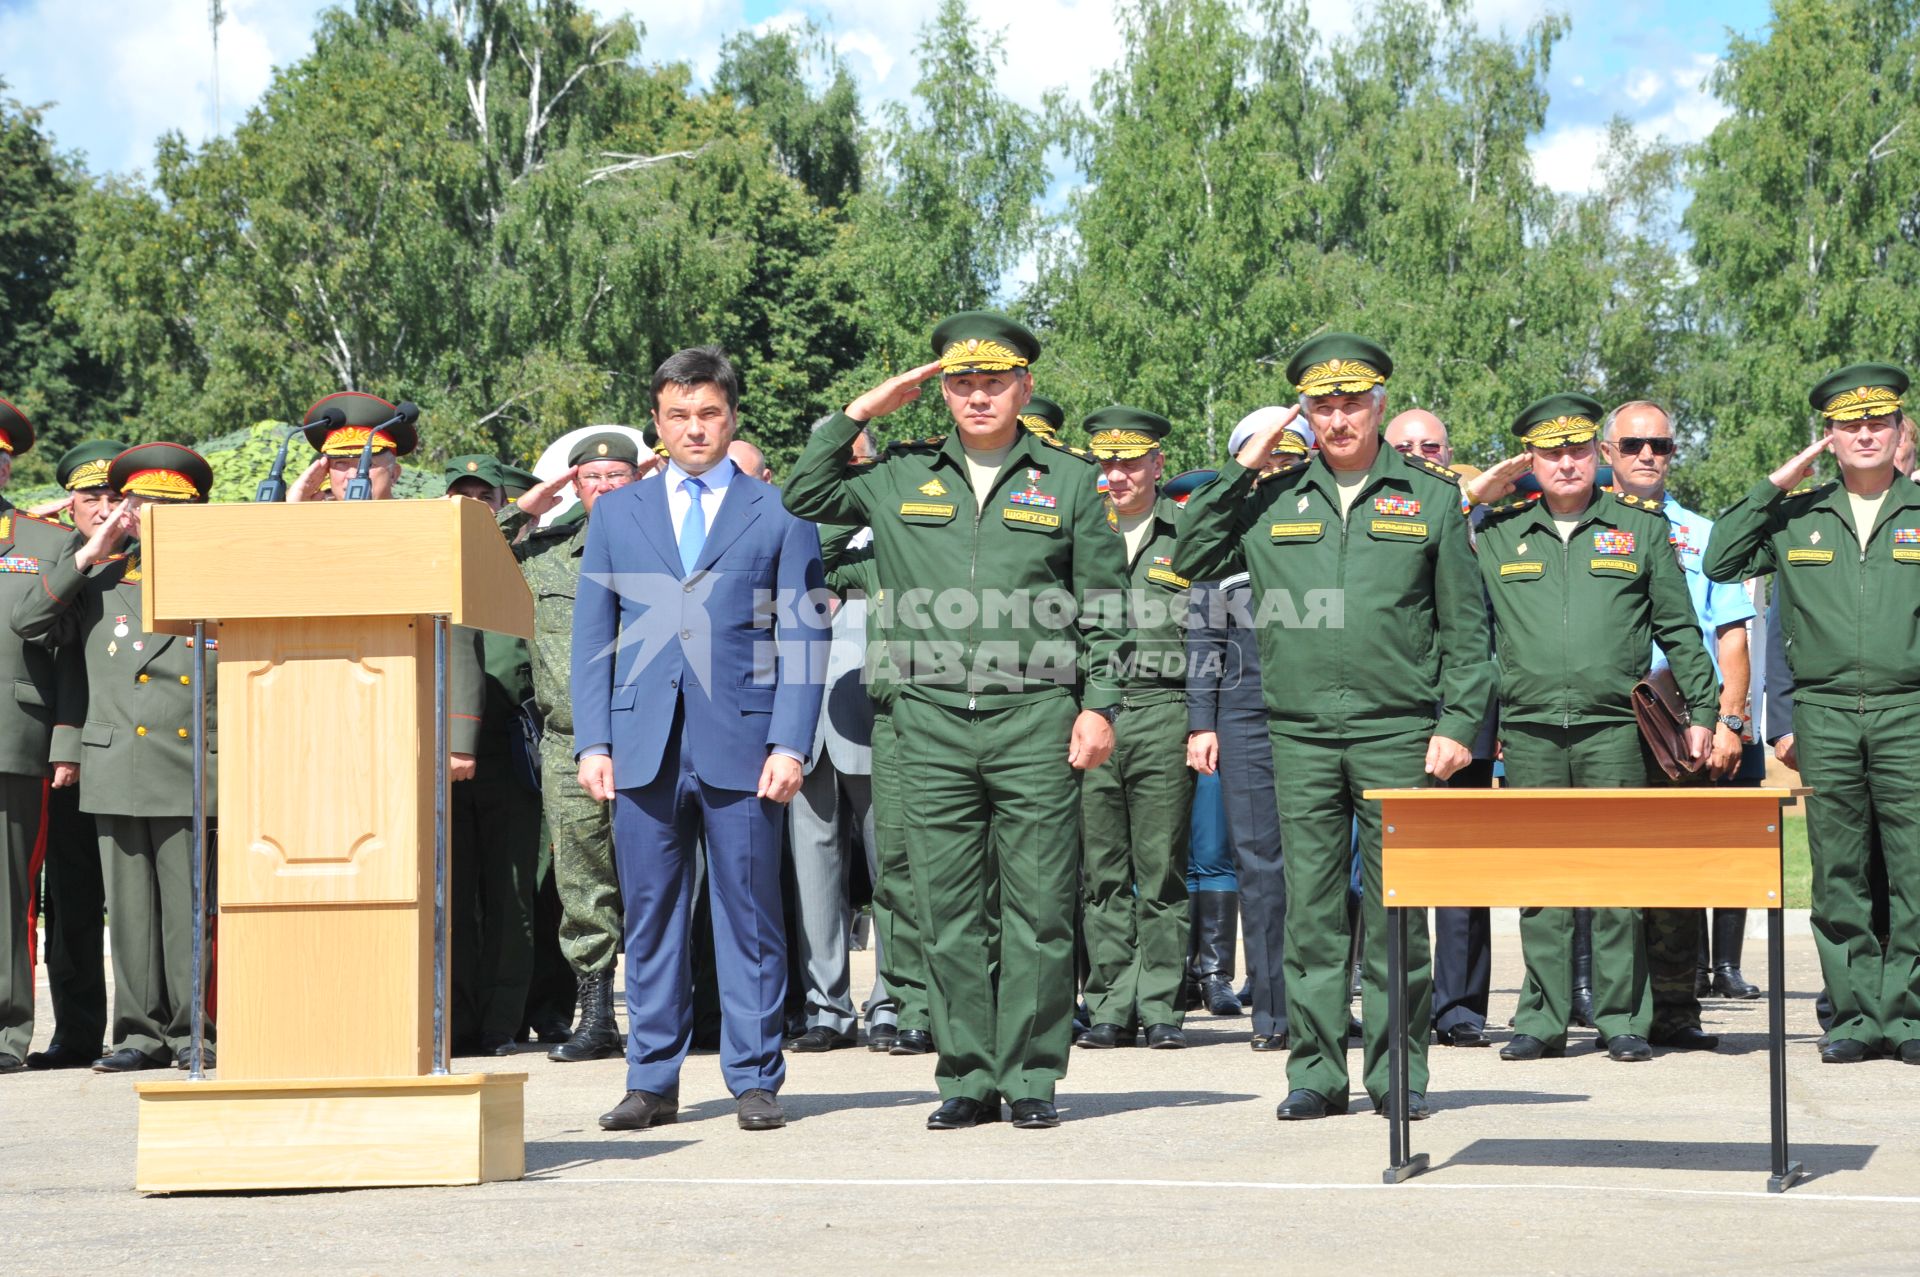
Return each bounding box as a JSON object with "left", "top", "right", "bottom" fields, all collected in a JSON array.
[{"left": 1478, "top": 492, "right": 1720, "bottom": 728}]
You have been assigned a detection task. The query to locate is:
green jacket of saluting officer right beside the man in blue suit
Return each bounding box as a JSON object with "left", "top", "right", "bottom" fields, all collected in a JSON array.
[{"left": 781, "top": 413, "right": 1127, "bottom": 709}]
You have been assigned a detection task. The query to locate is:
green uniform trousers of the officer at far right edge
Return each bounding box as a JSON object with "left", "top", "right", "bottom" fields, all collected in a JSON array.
[{"left": 1793, "top": 701, "right": 1920, "bottom": 1048}]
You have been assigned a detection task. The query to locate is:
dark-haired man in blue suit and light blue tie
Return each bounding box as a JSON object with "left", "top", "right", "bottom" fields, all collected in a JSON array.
[{"left": 572, "top": 346, "right": 828, "bottom": 1131}]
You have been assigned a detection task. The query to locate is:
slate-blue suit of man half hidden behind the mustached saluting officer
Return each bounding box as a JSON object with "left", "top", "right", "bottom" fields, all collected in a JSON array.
[{"left": 1187, "top": 572, "right": 1286, "bottom": 1037}]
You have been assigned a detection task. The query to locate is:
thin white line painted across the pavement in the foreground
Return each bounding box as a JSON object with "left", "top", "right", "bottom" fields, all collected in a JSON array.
[{"left": 522, "top": 1171, "right": 1920, "bottom": 1206}]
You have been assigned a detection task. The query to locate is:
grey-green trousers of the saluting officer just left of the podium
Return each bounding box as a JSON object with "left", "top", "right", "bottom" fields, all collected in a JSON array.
[{"left": 94, "top": 816, "right": 213, "bottom": 1064}]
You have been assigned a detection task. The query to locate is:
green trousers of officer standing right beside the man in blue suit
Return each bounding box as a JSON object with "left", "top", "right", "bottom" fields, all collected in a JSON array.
[{"left": 893, "top": 693, "right": 1081, "bottom": 1100}]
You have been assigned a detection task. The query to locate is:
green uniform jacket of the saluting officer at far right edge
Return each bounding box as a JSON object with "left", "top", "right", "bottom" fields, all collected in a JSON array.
[{"left": 1703, "top": 474, "right": 1920, "bottom": 711}]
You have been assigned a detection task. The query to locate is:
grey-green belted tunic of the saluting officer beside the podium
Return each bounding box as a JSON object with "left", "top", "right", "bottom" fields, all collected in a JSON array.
[{"left": 13, "top": 536, "right": 219, "bottom": 816}]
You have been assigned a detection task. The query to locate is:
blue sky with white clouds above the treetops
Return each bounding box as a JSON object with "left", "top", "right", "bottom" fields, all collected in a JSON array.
[{"left": 0, "top": 0, "right": 1768, "bottom": 190}]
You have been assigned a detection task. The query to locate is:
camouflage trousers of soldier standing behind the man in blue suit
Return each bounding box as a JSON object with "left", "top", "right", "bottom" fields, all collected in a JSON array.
[{"left": 540, "top": 728, "right": 624, "bottom": 976}]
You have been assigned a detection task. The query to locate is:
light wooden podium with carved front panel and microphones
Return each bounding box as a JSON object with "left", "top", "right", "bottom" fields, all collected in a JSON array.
[{"left": 134, "top": 501, "right": 534, "bottom": 1193}]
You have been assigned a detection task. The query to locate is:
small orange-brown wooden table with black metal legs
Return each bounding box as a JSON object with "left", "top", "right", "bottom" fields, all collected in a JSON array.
[{"left": 1365, "top": 785, "right": 1812, "bottom": 1193}]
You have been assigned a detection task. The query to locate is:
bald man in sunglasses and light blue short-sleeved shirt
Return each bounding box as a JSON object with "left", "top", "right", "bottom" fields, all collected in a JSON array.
[{"left": 1601, "top": 399, "right": 1766, "bottom": 1050}]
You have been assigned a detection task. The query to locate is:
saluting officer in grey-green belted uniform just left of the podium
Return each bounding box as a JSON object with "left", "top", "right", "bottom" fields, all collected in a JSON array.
[{"left": 12, "top": 444, "right": 219, "bottom": 1073}]
